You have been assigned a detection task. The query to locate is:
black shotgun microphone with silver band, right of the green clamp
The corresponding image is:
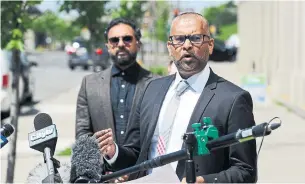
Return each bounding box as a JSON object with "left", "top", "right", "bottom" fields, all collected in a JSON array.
[{"left": 206, "top": 123, "right": 281, "bottom": 151}]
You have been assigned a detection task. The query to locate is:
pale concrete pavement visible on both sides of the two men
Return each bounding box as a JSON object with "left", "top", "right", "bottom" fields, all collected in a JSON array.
[{"left": 1, "top": 63, "right": 305, "bottom": 183}]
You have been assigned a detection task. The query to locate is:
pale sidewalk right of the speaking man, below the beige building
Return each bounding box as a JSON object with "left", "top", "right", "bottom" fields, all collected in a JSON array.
[{"left": 211, "top": 63, "right": 305, "bottom": 183}]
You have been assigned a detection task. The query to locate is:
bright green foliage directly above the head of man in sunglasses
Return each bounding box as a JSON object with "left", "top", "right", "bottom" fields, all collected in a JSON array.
[{"left": 112, "top": 0, "right": 147, "bottom": 26}]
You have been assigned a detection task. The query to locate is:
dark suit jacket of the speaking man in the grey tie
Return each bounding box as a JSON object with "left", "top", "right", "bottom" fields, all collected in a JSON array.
[{"left": 112, "top": 70, "right": 257, "bottom": 183}]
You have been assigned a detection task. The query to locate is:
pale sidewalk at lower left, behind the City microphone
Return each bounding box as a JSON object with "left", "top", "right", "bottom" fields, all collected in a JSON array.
[{"left": 1, "top": 86, "right": 79, "bottom": 183}]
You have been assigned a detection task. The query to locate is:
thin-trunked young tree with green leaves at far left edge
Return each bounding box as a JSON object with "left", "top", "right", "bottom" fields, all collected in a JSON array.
[{"left": 0, "top": 1, "right": 41, "bottom": 183}]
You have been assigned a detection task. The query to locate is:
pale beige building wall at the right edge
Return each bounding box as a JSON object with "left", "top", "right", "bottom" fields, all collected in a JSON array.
[{"left": 238, "top": 1, "right": 305, "bottom": 110}]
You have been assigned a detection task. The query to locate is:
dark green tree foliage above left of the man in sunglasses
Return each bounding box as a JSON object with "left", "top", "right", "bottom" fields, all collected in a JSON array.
[{"left": 60, "top": 1, "right": 109, "bottom": 46}]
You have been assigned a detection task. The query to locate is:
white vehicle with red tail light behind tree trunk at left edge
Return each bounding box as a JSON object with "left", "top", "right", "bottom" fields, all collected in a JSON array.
[{"left": 0, "top": 49, "right": 37, "bottom": 119}]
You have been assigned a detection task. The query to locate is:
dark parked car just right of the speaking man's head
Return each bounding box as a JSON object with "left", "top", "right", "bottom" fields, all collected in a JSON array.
[{"left": 209, "top": 38, "right": 237, "bottom": 61}]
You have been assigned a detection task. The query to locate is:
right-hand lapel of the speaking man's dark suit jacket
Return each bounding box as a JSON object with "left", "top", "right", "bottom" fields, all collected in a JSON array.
[{"left": 176, "top": 69, "right": 219, "bottom": 179}]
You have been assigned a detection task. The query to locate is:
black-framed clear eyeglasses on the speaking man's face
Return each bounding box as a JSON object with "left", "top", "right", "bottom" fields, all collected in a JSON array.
[{"left": 169, "top": 34, "right": 210, "bottom": 46}]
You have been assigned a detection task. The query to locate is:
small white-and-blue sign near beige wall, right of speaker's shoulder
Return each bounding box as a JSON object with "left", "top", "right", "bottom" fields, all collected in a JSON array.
[{"left": 241, "top": 73, "right": 267, "bottom": 103}]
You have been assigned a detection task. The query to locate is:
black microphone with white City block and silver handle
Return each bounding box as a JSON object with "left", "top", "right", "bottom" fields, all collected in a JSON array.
[{"left": 28, "top": 113, "right": 60, "bottom": 183}]
